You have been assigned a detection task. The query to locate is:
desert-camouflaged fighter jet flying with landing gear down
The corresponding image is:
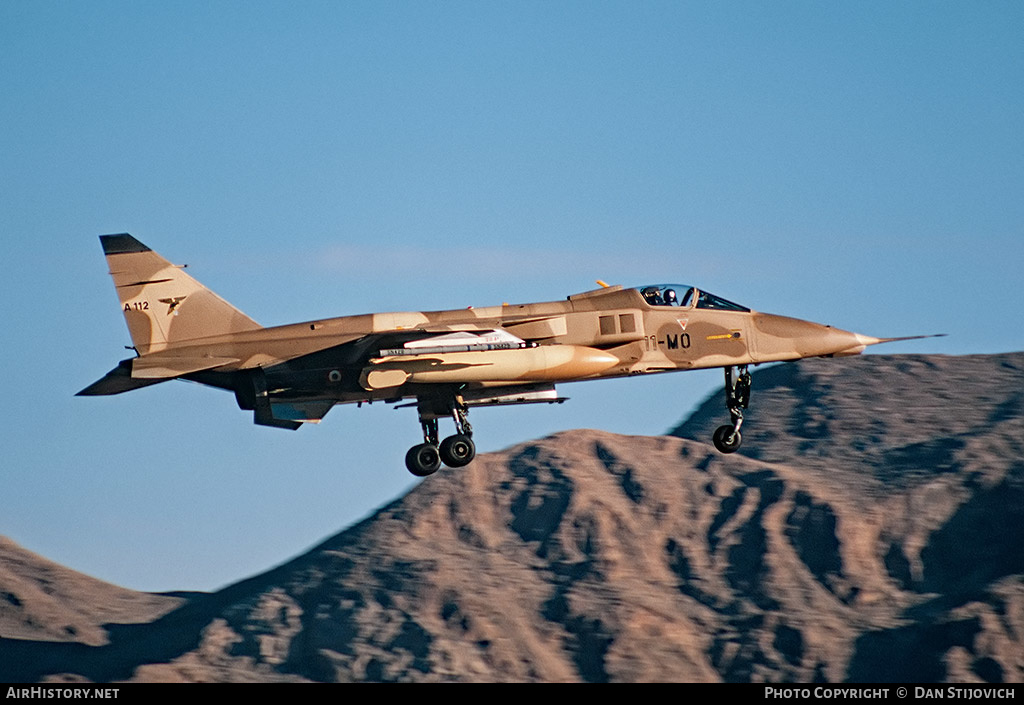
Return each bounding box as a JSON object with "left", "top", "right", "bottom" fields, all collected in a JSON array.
[{"left": 78, "top": 234, "right": 942, "bottom": 476}]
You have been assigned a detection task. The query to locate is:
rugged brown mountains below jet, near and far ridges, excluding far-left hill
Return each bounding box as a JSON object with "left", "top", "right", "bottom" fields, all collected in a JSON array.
[{"left": 0, "top": 355, "right": 1024, "bottom": 681}]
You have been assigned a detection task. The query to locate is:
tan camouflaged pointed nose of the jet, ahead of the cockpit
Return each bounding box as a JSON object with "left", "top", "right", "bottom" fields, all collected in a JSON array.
[{"left": 754, "top": 314, "right": 880, "bottom": 362}]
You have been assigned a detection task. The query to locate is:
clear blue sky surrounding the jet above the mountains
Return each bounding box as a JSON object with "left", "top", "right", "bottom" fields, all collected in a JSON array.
[{"left": 0, "top": 0, "right": 1024, "bottom": 590}]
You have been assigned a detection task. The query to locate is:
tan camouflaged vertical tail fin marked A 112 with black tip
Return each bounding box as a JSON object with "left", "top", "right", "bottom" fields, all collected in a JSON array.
[{"left": 99, "top": 234, "right": 260, "bottom": 355}]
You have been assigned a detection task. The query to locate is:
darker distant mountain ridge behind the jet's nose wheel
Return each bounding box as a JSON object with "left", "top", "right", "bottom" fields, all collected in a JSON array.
[{"left": 670, "top": 353, "right": 1024, "bottom": 492}]
